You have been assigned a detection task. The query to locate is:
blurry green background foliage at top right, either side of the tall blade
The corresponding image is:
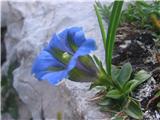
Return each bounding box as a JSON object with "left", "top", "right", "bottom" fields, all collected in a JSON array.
[{"left": 96, "top": 1, "right": 160, "bottom": 32}]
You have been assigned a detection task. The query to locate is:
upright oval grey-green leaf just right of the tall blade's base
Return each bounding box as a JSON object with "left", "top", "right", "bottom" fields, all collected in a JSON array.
[{"left": 117, "top": 63, "right": 132, "bottom": 86}]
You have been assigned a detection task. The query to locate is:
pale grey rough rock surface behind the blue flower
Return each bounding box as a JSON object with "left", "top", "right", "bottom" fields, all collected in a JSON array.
[{"left": 2, "top": 0, "right": 109, "bottom": 120}]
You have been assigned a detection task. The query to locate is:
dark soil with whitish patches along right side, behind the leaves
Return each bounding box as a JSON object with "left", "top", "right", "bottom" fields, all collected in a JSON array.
[{"left": 112, "top": 25, "right": 160, "bottom": 120}]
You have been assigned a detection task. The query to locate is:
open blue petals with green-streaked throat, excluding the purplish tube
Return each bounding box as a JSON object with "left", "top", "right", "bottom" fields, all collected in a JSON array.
[{"left": 32, "top": 27, "right": 96, "bottom": 84}]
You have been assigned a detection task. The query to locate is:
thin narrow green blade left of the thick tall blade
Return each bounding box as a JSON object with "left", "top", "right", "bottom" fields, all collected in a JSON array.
[{"left": 94, "top": 5, "right": 106, "bottom": 49}]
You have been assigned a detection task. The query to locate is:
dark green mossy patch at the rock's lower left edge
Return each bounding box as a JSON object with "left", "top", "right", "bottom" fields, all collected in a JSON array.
[{"left": 1, "top": 61, "right": 19, "bottom": 119}]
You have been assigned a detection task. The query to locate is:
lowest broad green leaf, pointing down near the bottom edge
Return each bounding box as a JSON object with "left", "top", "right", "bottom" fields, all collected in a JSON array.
[{"left": 124, "top": 99, "right": 143, "bottom": 120}]
